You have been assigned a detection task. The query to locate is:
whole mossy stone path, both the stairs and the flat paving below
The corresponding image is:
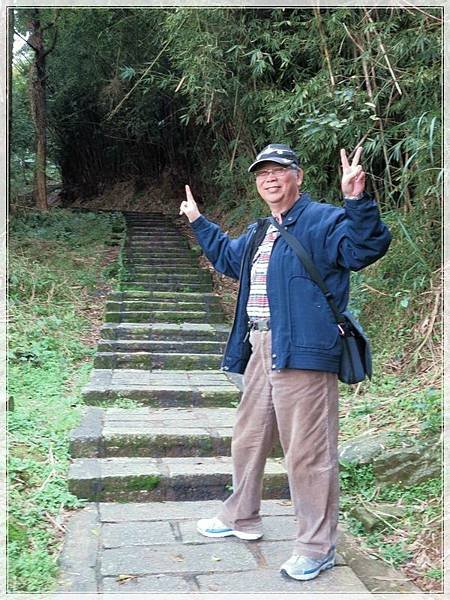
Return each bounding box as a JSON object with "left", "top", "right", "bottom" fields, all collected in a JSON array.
[{"left": 57, "top": 213, "right": 426, "bottom": 599}]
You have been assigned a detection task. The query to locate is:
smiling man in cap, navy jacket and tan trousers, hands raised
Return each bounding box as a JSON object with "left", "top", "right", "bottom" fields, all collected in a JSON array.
[{"left": 180, "top": 144, "right": 390, "bottom": 580}]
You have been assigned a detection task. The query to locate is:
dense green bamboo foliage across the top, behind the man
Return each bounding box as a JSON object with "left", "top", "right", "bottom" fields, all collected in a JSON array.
[{"left": 12, "top": 8, "right": 442, "bottom": 208}]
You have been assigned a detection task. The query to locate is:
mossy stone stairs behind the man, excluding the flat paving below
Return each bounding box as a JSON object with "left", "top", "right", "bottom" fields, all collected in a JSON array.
[{"left": 69, "top": 214, "right": 289, "bottom": 502}]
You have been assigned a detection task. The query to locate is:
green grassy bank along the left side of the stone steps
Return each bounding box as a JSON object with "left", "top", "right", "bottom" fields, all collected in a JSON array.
[{"left": 7, "top": 209, "right": 123, "bottom": 592}]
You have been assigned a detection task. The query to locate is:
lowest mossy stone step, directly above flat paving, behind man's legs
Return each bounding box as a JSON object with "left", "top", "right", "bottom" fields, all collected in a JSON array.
[{"left": 68, "top": 456, "right": 290, "bottom": 502}]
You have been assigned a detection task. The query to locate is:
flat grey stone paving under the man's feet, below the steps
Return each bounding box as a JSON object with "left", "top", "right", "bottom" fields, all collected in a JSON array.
[{"left": 60, "top": 500, "right": 367, "bottom": 593}]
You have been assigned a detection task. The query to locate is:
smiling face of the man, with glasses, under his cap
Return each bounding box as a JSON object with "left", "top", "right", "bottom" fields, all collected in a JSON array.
[{"left": 255, "top": 162, "right": 303, "bottom": 213}]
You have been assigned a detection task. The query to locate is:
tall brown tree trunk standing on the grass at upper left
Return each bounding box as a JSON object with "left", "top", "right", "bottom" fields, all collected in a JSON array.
[{"left": 28, "top": 9, "right": 48, "bottom": 210}]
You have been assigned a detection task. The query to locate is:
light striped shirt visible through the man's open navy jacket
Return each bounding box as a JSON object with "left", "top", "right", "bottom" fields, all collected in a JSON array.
[{"left": 247, "top": 225, "right": 280, "bottom": 319}]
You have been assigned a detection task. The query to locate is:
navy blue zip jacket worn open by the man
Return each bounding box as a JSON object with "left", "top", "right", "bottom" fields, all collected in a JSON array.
[{"left": 191, "top": 193, "right": 391, "bottom": 373}]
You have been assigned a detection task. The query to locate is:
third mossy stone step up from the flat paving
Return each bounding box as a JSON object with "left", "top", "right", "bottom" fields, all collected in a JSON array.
[{"left": 81, "top": 369, "right": 241, "bottom": 408}]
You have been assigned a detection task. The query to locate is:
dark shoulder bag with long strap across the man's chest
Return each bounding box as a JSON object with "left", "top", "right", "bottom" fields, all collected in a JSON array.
[{"left": 270, "top": 218, "right": 372, "bottom": 384}]
